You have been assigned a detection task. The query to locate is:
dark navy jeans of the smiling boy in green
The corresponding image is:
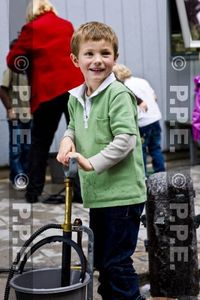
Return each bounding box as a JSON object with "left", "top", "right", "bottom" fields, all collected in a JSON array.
[{"left": 90, "top": 203, "right": 144, "bottom": 300}]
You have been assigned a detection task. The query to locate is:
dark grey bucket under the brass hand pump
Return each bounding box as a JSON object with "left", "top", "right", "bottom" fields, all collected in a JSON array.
[{"left": 10, "top": 268, "right": 90, "bottom": 300}]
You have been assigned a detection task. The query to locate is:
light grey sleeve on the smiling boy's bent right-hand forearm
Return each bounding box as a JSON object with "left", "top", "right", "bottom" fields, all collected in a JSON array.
[{"left": 89, "top": 134, "right": 136, "bottom": 173}]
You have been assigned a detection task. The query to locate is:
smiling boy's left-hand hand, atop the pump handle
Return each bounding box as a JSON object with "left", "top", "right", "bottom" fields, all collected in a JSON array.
[{"left": 56, "top": 136, "right": 76, "bottom": 165}]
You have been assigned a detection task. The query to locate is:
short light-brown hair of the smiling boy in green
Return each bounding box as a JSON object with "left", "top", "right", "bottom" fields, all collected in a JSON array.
[{"left": 71, "top": 21, "right": 118, "bottom": 58}]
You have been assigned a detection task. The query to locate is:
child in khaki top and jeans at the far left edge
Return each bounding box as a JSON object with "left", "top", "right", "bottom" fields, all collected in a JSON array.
[{"left": 0, "top": 40, "right": 31, "bottom": 190}]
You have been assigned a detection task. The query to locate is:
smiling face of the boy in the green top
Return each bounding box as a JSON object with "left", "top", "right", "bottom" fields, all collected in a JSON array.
[{"left": 71, "top": 40, "right": 116, "bottom": 96}]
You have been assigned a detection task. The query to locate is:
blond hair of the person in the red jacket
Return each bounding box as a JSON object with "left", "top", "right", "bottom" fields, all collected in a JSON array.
[{"left": 26, "top": 0, "right": 57, "bottom": 22}]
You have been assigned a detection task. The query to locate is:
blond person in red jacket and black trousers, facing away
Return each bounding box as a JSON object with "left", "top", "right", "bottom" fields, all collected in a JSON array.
[{"left": 7, "top": 0, "right": 83, "bottom": 203}]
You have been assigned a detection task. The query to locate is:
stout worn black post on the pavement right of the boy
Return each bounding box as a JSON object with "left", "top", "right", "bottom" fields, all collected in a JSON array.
[{"left": 146, "top": 171, "right": 199, "bottom": 299}]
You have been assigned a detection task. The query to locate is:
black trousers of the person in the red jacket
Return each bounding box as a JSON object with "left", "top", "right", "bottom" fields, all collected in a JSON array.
[{"left": 27, "top": 93, "right": 69, "bottom": 196}]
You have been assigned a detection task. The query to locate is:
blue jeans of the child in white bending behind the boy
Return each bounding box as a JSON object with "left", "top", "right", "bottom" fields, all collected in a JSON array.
[{"left": 139, "top": 121, "right": 165, "bottom": 174}]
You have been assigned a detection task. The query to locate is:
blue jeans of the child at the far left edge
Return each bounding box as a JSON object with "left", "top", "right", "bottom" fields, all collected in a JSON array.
[{"left": 8, "top": 119, "right": 31, "bottom": 184}]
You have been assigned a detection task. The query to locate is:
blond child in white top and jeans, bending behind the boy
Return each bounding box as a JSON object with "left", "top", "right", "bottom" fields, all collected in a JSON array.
[{"left": 113, "top": 64, "right": 165, "bottom": 175}]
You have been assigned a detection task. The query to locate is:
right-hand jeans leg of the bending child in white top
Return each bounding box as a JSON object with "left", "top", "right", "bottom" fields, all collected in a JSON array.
[{"left": 148, "top": 121, "right": 165, "bottom": 173}]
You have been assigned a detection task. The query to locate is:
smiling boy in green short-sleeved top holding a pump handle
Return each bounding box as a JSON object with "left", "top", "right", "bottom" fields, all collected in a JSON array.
[{"left": 57, "top": 22, "right": 146, "bottom": 300}]
